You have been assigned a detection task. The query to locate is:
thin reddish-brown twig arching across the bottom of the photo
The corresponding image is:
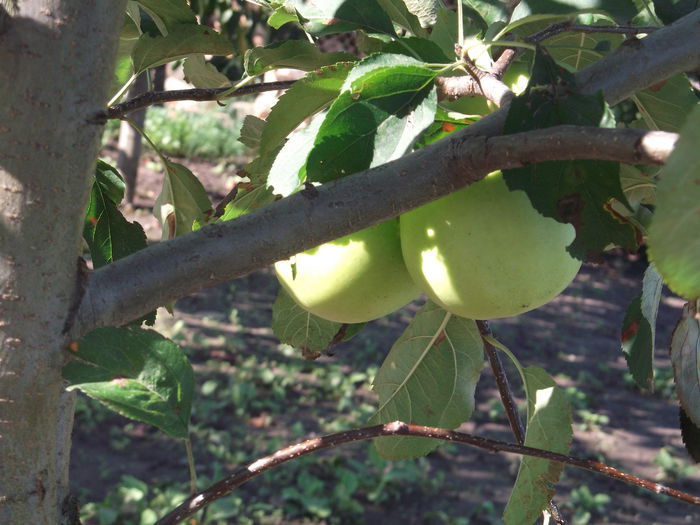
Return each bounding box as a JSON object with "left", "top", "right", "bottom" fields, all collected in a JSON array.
[{"left": 156, "top": 421, "right": 700, "bottom": 525}]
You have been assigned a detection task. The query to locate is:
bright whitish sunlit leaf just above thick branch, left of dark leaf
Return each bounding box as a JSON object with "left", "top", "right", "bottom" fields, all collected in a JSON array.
[{"left": 267, "top": 114, "right": 325, "bottom": 197}]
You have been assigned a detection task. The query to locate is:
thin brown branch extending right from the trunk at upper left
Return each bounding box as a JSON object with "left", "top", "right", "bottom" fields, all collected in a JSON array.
[{"left": 90, "top": 80, "right": 296, "bottom": 124}]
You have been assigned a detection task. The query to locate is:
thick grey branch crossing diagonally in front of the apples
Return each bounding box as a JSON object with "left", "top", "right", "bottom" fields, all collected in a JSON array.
[{"left": 70, "top": 126, "right": 677, "bottom": 338}]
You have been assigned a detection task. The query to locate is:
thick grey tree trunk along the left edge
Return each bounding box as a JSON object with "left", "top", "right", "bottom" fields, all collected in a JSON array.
[{"left": 0, "top": 0, "right": 125, "bottom": 525}]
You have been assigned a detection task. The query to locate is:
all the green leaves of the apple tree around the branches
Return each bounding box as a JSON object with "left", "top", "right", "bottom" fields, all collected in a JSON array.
[{"left": 63, "top": 0, "right": 700, "bottom": 524}]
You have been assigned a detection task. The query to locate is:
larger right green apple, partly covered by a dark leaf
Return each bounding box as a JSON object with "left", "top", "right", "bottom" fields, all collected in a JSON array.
[{"left": 401, "top": 172, "right": 581, "bottom": 319}]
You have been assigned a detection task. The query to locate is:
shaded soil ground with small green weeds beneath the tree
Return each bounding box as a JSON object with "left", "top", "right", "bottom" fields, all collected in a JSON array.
[{"left": 71, "top": 147, "right": 700, "bottom": 525}]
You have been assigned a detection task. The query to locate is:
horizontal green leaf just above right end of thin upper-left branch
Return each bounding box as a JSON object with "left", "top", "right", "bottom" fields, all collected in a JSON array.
[{"left": 243, "top": 40, "right": 357, "bottom": 77}]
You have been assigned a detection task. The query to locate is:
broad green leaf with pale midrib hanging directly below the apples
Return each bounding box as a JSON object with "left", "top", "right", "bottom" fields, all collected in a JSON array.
[{"left": 370, "top": 302, "right": 484, "bottom": 459}]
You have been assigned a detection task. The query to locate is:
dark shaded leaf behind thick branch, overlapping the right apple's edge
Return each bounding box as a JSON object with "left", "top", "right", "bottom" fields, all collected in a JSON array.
[{"left": 504, "top": 51, "right": 637, "bottom": 260}]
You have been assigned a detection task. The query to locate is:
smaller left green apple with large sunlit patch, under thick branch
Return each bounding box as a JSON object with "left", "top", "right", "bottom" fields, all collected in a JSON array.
[{"left": 275, "top": 219, "right": 420, "bottom": 323}]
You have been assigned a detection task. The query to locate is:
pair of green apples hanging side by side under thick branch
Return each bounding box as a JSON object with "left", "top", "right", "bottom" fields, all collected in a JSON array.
[{"left": 275, "top": 172, "right": 581, "bottom": 323}]
